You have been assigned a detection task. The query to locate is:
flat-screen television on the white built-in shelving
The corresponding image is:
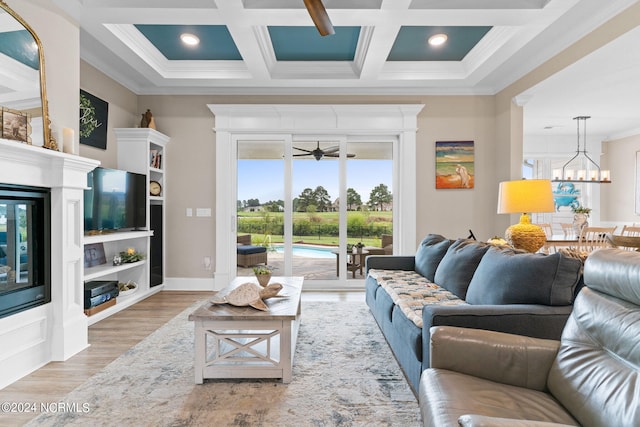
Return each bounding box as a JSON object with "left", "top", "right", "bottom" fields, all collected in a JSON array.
[{"left": 84, "top": 167, "right": 147, "bottom": 233}]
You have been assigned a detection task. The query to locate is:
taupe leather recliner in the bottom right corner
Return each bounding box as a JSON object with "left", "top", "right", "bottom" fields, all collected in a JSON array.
[{"left": 419, "top": 248, "right": 640, "bottom": 427}]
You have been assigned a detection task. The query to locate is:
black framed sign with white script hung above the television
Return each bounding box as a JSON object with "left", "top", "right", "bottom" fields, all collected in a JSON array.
[{"left": 80, "top": 89, "right": 109, "bottom": 150}]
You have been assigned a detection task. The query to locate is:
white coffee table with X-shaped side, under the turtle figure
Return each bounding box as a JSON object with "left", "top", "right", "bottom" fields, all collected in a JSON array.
[{"left": 189, "top": 277, "right": 303, "bottom": 384}]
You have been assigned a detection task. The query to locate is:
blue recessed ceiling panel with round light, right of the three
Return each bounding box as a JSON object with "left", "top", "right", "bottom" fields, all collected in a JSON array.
[{"left": 387, "top": 26, "right": 491, "bottom": 61}]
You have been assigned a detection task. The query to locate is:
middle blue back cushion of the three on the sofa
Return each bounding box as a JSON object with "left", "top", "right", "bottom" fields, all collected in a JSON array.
[{"left": 433, "top": 239, "right": 491, "bottom": 300}]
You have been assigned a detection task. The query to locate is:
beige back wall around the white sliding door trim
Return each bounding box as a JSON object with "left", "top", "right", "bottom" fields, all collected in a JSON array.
[{"left": 131, "top": 96, "right": 509, "bottom": 278}]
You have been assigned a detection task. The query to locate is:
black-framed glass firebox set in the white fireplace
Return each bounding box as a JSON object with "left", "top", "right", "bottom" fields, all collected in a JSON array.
[{"left": 0, "top": 184, "right": 51, "bottom": 318}]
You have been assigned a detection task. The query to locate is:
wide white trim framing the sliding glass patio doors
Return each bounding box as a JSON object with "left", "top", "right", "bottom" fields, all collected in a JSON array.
[{"left": 207, "top": 104, "right": 424, "bottom": 289}]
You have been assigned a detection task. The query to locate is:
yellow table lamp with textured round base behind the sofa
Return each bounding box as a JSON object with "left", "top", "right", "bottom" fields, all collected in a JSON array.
[{"left": 498, "top": 179, "right": 555, "bottom": 252}]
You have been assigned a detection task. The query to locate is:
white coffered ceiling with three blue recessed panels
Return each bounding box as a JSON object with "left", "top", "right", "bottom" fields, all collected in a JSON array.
[{"left": 52, "top": 0, "right": 638, "bottom": 139}]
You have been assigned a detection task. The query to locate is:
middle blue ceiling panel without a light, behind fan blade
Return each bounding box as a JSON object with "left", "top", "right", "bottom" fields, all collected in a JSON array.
[{"left": 268, "top": 26, "right": 360, "bottom": 61}]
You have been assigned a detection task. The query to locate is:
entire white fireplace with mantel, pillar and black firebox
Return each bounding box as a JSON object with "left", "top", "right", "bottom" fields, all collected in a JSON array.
[{"left": 0, "top": 139, "right": 100, "bottom": 388}]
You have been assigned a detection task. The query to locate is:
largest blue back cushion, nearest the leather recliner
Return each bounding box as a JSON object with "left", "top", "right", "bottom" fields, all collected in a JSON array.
[{"left": 466, "top": 247, "right": 582, "bottom": 305}]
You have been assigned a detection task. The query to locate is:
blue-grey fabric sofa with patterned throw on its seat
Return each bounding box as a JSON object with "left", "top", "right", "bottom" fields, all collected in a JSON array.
[{"left": 366, "top": 234, "right": 582, "bottom": 394}]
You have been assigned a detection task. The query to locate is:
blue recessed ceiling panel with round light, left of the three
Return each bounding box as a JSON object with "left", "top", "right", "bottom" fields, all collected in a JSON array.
[{"left": 135, "top": 25, "right": 242, "bottom": 61}]
